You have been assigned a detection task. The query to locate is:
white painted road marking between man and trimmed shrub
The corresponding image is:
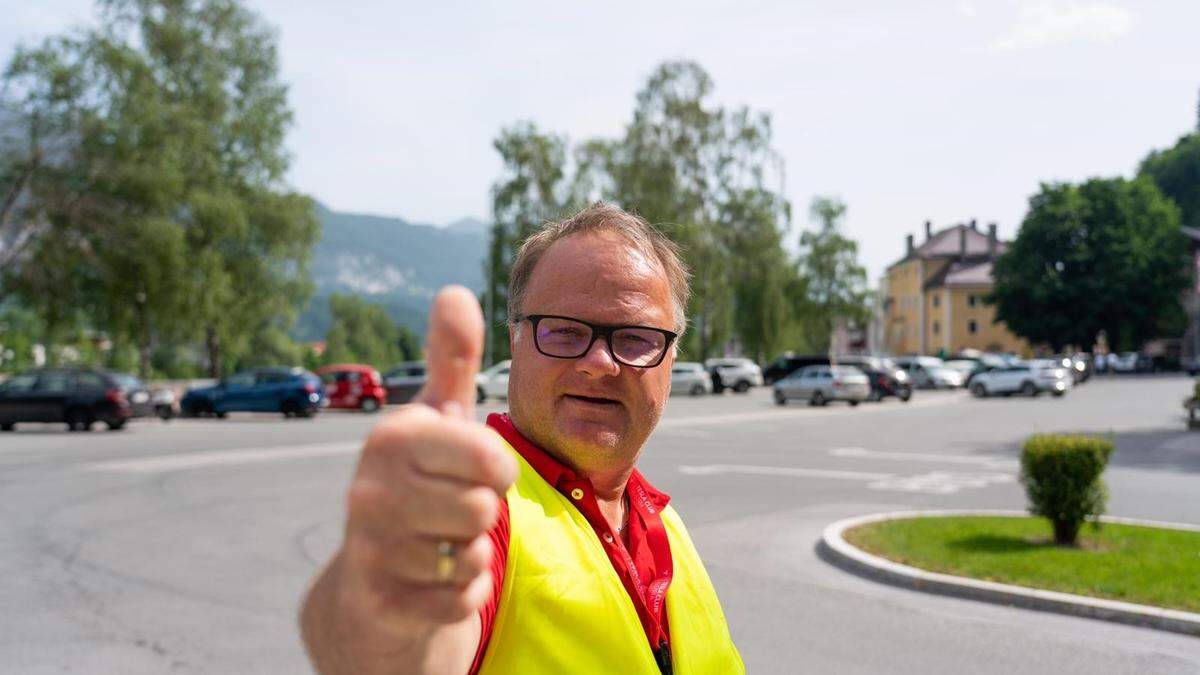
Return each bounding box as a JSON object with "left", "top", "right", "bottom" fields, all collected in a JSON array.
[{"left": 679, "top": 464, "right": 1015, "bottom": 495}]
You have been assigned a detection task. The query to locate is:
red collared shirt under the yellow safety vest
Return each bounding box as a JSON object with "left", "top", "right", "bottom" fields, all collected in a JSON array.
[{"left": 469, "top": 413, "right": 672, "bottom": 675}]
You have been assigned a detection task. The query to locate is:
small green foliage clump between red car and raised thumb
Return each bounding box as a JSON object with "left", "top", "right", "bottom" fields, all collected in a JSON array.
[{"left": 323, "top": 294, "right": 421, "bottom": 370}]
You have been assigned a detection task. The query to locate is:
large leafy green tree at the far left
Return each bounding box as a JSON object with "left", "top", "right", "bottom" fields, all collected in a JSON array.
[{"left": 5, "top": 0, "right": 318, "bottom": 376}]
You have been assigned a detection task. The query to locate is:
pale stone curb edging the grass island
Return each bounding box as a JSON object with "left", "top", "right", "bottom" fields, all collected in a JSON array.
[{"left": 817, "top": 510, "right": 1200, "bottom": 637}]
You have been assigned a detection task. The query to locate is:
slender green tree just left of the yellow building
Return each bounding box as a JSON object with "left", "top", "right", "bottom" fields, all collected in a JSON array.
[{"left": 794, "top": 197, "right": 870, "bottom": 352}]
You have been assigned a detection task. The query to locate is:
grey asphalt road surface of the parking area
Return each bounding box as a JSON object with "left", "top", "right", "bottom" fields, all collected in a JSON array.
[{"left": 0, "top": 377, "right": 1200, "bottom": 675}]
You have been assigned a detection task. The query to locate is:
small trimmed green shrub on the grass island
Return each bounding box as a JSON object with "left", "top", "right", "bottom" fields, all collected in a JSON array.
[{"left": 1021, "top": 434, "right": 1112, "bottom": 546}]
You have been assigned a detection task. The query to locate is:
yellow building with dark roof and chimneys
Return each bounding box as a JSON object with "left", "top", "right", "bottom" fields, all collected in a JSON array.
[{"left": 882, "top": 221, "right": 1032, "bottom": 356}]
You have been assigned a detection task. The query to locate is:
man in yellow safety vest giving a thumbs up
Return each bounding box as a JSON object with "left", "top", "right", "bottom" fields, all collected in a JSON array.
[{"left": 301, "top": 204, "right": 744, "bottom": 675}]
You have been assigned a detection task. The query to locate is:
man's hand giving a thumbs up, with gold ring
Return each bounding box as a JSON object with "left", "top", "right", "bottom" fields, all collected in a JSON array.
[{"left": 301, "top": 287, "right": 516, "bottom": 675}]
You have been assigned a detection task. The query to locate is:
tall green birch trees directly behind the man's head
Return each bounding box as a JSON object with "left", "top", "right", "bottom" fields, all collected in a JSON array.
[{"left": 484, "top": 61, "right": 796, "bottom": 362}]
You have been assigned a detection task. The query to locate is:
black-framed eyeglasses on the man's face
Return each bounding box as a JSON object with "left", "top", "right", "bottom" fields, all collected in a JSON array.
[{"left": 518, "top": 315, "right": 679, "bottom": 368}]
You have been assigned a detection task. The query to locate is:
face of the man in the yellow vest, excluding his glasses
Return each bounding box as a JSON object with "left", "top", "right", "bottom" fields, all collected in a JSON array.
[{"left": 509, "top": 232, "right": 674, "bottom": 473}]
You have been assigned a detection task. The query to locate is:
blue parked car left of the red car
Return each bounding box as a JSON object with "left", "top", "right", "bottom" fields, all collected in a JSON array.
[{"left": 179, "top": 368, "right": 326, "bottom": 417}]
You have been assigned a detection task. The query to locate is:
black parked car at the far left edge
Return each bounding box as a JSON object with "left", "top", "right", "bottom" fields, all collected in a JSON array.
[{"left": 0, "top": 368, "right": 140, "bottom": 431}]
